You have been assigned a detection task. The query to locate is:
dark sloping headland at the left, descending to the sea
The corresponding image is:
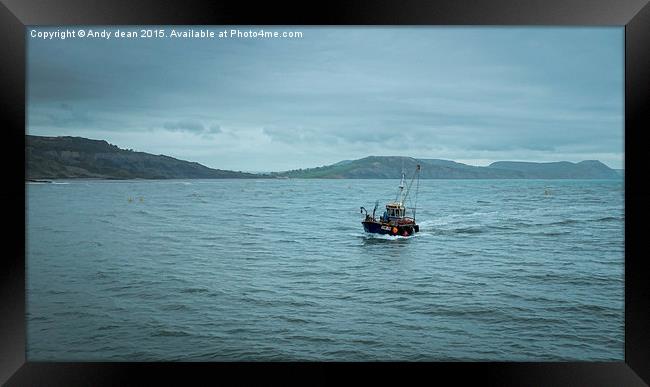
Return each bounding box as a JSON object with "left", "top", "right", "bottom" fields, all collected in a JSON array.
[{"left": 26, "top": 135, "right": 264, "bottom": 179}]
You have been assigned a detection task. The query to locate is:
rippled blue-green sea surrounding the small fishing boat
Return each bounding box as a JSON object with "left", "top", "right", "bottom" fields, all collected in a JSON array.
[{"left": 26, "top": 179, "right": 624, "bottom": 361}]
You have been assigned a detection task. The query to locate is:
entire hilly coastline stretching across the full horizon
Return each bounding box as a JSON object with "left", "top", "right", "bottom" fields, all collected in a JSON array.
[{"left": 26, "top": 135, "right": 622, "bottom": 180}]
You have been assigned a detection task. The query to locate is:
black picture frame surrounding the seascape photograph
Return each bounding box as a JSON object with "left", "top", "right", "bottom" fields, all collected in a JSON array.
[{"left": 0, "top": 0, "right": 650, "bottom": 386}]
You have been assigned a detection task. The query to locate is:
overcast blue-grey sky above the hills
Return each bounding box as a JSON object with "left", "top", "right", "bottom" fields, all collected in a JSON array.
[{"left": 27, "top": 27, "right": 624, "bottom": 171}]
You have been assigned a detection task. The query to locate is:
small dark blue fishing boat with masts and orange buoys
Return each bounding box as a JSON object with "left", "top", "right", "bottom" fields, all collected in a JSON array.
[{"left": 361, "top": 164, "right": 420, "bottom": 236}]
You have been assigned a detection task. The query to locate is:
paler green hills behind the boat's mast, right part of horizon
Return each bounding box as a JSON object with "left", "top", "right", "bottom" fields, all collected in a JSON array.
[{"left": 271, "top": 156, "right": 621, "bottom": 179}]
